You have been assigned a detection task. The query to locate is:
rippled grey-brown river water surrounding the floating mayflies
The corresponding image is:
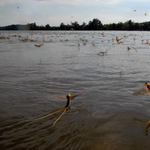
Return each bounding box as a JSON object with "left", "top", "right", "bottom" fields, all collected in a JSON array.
[{"left": 0, "top": 31, "right": 150, "bottom": 150}]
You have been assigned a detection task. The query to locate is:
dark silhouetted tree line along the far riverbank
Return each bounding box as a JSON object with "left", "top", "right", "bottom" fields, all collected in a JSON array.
[{"left": 0, "top": 18, "right": 150, "bottom": 31}]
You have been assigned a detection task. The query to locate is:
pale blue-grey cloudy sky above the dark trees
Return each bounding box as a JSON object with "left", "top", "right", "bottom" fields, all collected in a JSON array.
[{"left": 0, "top": 0, "right": 150, "bottom": 26}]
